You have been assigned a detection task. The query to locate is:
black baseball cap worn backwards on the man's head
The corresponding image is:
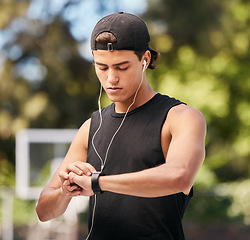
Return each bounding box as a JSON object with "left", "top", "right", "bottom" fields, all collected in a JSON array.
[{"left": 91, "top": 12, "right": 154, "bottom": 51}]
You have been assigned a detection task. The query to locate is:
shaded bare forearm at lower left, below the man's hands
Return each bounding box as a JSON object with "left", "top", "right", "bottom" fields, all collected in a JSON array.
[{"left": 36, "top": 188, "right": 72, "bottom": 222}]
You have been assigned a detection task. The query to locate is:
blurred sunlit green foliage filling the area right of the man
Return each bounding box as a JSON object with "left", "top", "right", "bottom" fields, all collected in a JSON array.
[{"left": 145, "top": 0, "right": 250, "bottom": 224}]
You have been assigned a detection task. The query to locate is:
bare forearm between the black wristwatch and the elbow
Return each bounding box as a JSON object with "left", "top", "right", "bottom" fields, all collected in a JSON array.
[{"left": 99, "top": 164, "right": 193, "bottom": 197}]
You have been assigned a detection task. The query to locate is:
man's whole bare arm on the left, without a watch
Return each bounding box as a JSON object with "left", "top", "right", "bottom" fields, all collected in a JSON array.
[{"left": 36, "top": 120, "right": 95, "bottom": 221}]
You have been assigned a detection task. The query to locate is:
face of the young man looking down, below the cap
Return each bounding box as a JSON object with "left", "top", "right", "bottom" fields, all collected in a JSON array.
[{"left": 93, "top": 50, "right": 143, "bottom": 103}]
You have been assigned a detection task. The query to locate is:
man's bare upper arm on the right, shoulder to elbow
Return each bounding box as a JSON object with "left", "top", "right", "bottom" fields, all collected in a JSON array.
[{"left": 166, "top": 106, "right": 206, "bottom": 185}]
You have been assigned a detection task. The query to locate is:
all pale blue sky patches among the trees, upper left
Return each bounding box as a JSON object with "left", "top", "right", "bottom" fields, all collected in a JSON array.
[{"left": 0, "top": 0, "right": 148, "bottom": 81}]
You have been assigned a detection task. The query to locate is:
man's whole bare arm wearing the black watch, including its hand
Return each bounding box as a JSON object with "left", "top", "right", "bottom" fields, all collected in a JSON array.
[{"left": 67, "top": 105, "right": 206, "bottom": 197}]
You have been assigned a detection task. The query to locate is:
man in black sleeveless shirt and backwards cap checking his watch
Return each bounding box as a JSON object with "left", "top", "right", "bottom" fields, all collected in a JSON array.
[{"left": 37, "top": 12, "right": 206, "bottom": 240}]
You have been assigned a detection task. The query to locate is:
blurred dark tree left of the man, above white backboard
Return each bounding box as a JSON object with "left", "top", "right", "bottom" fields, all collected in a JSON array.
[{"left": 0, "top": 1, "right": 99, "bottom": 185}]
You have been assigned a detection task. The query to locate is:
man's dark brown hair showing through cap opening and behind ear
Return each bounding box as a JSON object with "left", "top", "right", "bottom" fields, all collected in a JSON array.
[{"left": 96, "top": 32, "right": 160, "bottom": 69}]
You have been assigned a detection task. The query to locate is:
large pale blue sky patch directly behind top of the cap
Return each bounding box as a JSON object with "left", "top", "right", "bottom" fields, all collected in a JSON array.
[{"left": 27, "top": 0, "right": 147, "bottom": 41}]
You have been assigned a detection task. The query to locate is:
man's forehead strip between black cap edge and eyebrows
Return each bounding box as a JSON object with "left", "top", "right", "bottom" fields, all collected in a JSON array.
[{"left": 93, "top": 50, "right": 139, "bottom": 65}]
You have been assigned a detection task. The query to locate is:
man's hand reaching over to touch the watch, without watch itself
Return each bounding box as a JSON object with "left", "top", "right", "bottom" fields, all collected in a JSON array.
[{"left": 59, "top": 161, "right": 96, "bottom": 197}]
